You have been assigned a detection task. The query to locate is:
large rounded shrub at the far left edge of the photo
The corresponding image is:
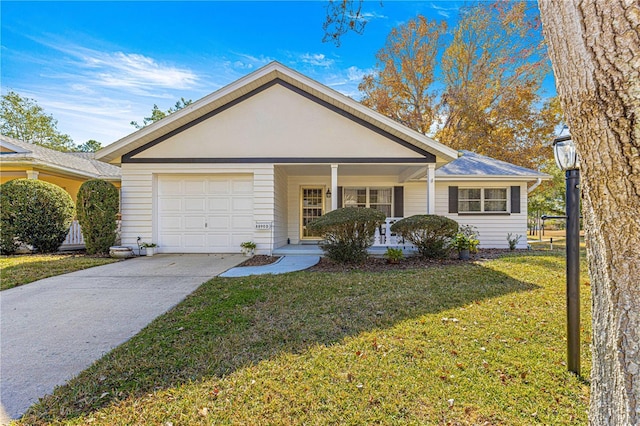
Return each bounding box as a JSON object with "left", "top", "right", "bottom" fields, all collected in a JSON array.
[{"left": 0, "top": 179, "right": 75, "bottom": 253}]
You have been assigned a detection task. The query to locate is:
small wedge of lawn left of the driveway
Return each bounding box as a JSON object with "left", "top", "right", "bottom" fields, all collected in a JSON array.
[{"left": 0, "top": 254, "right": 117, "bottom": 290}]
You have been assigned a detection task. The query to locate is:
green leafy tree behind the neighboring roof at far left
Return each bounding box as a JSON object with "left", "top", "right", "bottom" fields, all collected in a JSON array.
[{"left": 0, "top": 91, "right": 76, "bottom": 151}]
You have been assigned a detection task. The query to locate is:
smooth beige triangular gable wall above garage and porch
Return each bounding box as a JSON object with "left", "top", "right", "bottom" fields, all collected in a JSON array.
[{"left": 134, "top": 85, "right": 423, "bottom": 158}]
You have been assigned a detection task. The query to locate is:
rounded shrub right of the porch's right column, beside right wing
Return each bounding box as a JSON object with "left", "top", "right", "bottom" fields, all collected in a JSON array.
[{"left": 391, "top": 214, "right": 458, "bottom": 258}]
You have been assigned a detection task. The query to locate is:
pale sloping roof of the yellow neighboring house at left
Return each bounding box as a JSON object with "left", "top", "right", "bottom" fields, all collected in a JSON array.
[{"left": 0, "top": 135, "right": 120, "bottom": 180}]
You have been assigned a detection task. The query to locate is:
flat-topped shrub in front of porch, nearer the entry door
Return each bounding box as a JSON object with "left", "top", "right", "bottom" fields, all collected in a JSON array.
[{"left": 308, "top": 207, "right": 386, "bottom": 263}]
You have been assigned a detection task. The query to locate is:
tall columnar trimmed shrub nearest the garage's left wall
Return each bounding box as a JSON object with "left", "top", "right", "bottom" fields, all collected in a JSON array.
[{"left": 76, "top": 179, "right": 120, "bottom": 254}]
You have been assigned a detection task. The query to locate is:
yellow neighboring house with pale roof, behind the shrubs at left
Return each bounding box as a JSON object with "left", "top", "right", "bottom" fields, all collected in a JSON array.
[{"left": 0, "top": 135, "right": 120, "bottom": 202}]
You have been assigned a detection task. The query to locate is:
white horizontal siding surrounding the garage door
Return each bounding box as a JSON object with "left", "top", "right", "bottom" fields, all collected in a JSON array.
[{"left": 122, "top": 163, "right": 275, "bottom": 253}]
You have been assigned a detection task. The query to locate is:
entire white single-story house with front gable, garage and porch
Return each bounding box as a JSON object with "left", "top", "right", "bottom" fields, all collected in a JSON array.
[{"left": 96, "top": 62, "right": 547, "bottom": 253}]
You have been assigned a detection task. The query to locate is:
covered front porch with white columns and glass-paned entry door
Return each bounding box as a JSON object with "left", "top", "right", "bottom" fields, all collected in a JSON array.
[{"left": 268, "top": 163, "right": 435, "bottom": 254}]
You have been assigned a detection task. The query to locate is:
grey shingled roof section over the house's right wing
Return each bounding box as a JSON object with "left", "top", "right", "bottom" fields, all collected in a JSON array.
[{"left": 436, "top": 150, "right": 551, "bottom": 181}]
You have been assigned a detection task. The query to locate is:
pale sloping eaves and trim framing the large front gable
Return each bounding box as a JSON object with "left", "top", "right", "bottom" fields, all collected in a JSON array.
[{"left": 96, "top": 62, "right": 458, "bottom": 163}]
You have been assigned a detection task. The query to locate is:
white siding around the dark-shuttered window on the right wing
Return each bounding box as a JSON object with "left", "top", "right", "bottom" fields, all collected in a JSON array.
[{"left": 436, "top": 181, "right": 527, "bottom": 248}]
